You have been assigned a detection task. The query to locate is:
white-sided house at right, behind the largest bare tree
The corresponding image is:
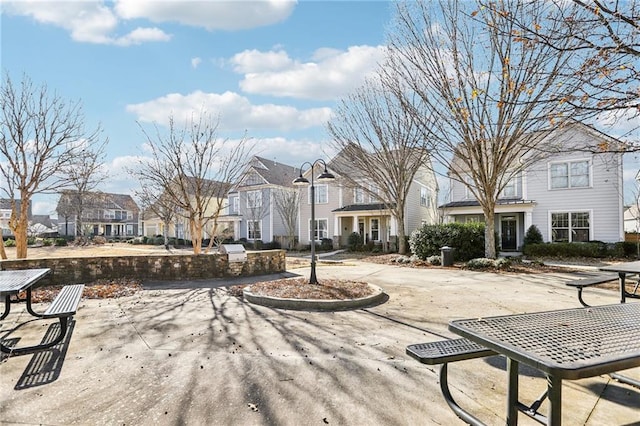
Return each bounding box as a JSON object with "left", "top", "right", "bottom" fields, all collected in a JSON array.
[{"left": 440, "top": 122, "right": 624, "bottom": 252}]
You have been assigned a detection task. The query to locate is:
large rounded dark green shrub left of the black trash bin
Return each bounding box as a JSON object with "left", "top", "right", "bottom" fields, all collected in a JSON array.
[{"left": 409, "top": 222, "right": 485, "bottom": 261}]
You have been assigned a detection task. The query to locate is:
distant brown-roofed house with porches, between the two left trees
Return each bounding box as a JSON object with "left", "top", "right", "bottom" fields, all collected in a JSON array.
[{"left": 56, "top": 191, "right": 139, "bottom": 238}]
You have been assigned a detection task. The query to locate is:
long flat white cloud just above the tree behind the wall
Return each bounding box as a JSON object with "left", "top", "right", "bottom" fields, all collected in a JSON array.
[{"left": 126, "top": 91, "right": 331, "bottom": 131}]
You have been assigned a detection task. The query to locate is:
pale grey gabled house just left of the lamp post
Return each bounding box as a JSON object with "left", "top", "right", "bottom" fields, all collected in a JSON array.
[{"left": 221, "top": 156, "right": 299, "bottom": 246}]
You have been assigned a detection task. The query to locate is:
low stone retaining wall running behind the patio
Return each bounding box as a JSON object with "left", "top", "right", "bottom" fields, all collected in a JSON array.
[{"left": 0, "top": 250, "right": 286, "bottom": 285}]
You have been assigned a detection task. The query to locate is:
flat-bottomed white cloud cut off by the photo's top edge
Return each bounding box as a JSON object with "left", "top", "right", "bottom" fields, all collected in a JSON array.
[{"left": 115, "top": 0, "right": 296, "bottom": 30}]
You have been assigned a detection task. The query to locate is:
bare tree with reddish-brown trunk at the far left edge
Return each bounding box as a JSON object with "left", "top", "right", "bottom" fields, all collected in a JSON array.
[{"left": 0, "top": 74, "right": 100, "bottom": 259}]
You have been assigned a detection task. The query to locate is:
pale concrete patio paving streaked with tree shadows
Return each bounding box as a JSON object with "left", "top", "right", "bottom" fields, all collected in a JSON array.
[{"left": 0, "top": 262, "right": 640, "bottom": 425}]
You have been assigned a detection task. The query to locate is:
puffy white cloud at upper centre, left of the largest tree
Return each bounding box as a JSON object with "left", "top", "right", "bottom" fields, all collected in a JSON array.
[{"left": 231, "top": 46, "right": 384, "bottom": 100}]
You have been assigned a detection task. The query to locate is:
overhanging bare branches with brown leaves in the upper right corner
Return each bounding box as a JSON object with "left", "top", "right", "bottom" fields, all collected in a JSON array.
[{"left": 496, "top": 0, "right": 640, "bottom": 115}]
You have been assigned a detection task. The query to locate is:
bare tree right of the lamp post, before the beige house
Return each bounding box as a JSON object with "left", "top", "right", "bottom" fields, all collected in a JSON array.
[{"left": 327, "top": 79, "right": 429, "bottom": 254}]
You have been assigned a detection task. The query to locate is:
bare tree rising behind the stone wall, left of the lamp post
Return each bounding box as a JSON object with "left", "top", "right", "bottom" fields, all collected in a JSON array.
[{"left": 130, "top": 111, "right": 253, "bottom": 254}]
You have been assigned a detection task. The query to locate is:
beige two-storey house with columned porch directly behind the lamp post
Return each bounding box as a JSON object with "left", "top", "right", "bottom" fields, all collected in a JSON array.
[{"left": 299, "top": 154, "right": 438, "bottom": 251}]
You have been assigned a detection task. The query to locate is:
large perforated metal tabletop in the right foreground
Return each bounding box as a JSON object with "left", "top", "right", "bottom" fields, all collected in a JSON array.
[{"left": 449, "top": 303, "right": 640, "bottom": 380}]
